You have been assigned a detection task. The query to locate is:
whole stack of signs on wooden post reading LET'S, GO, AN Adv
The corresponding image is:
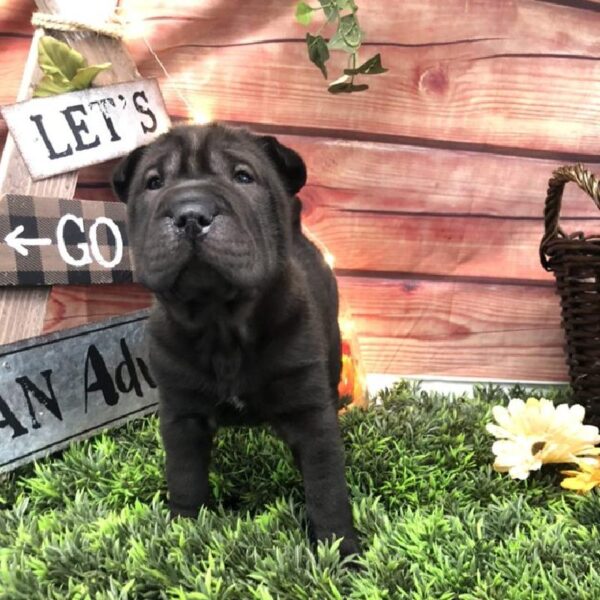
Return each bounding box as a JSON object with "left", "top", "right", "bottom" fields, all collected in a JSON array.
[{"left": 0, "top": 0, "right": 170, "bottom": 473}]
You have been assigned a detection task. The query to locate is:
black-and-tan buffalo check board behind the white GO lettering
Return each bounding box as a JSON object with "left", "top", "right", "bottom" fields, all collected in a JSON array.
[{"left": 0, "top": 194, "right": 134, "bottom": 286}]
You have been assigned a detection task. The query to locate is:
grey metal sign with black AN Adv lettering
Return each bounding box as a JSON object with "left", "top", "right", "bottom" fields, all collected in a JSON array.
[{"left": 0, "top": 311, "right": 158, "bottom": 473}]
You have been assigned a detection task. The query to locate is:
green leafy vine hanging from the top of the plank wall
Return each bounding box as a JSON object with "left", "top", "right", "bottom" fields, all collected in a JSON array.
[{"left": 296, "top": 0, "right": 388, "bottom": 94}]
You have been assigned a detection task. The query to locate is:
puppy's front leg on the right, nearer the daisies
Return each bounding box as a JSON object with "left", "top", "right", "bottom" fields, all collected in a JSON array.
[{"left": 274, "top": 404, "right": 358, "bottom": 556}]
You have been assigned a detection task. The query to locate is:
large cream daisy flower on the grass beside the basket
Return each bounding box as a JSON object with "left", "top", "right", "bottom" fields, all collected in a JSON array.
[{"left": 486, "top": 398, "right": 600, "bottom": 479}]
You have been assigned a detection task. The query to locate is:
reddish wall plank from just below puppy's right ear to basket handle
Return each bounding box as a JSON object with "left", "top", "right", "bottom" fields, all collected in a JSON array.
[{"left": 306, "top": 208, "right": 600, "bottom": 281}]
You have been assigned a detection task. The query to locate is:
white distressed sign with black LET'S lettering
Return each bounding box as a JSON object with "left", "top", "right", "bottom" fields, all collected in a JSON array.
[{"left": 0, "top": 79, "right": 170, "bottom": 180}]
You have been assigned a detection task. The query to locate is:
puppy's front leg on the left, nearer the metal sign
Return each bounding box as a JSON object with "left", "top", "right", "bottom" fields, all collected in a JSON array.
[{"left": 159, "top": 398, "right": 213, "bottom": 517}]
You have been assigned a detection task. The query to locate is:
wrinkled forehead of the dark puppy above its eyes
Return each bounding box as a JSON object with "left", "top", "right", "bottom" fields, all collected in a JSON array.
[{"left": 139, "top": 127, "right": 263, "bottom": 177}]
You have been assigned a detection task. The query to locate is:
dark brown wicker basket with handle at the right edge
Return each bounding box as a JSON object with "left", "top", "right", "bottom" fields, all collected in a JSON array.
[{"left": 540, "top": 165, "right": 600, "bottom": 425}]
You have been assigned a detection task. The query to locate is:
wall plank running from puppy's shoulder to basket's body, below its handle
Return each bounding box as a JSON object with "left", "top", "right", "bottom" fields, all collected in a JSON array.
[{"left": 338, "top": 275, "right": 560, "bottom": 341}]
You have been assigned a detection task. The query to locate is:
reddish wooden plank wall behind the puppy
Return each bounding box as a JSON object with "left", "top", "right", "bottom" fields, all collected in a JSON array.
[{"left": 0, "top": 0, "right": 600, "bottom": 381}]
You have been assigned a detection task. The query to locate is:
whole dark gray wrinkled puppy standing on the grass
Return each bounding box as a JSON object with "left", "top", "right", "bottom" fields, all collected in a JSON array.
[{"left": 113, "top": 124, "right": 357, "bottom": 554}]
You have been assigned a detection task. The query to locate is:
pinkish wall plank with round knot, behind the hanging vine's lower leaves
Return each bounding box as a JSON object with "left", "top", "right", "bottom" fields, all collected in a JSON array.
[{"left": 140, "top": 47, "right": 600, "bottom": 156}]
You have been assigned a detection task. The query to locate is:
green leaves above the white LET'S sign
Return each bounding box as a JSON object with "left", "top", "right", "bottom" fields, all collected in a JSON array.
[{"left": 33, "top": 35, "right": 111, "bottom": 98}]
